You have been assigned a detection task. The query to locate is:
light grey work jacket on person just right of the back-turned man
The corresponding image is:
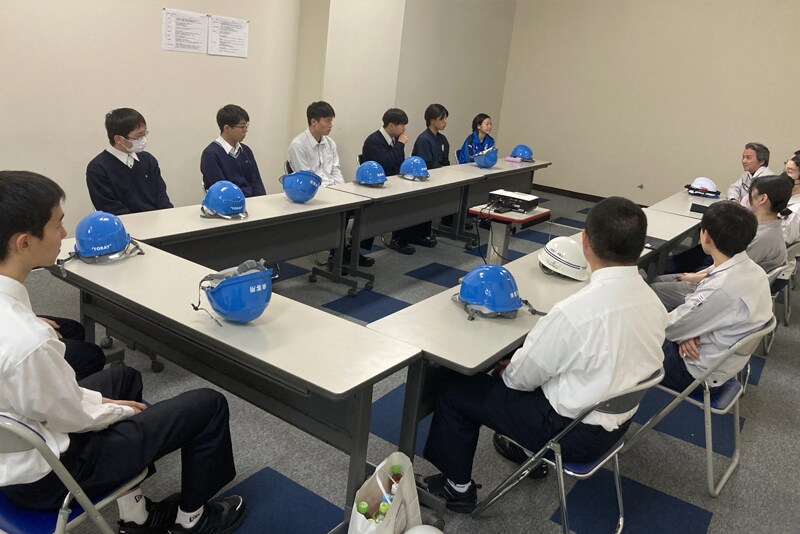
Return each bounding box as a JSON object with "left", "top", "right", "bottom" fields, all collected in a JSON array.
[{"left": 667, "top": 252, "right": 772, "bottom": 386}]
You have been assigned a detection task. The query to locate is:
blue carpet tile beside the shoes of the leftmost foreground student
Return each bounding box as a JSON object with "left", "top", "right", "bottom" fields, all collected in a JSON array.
[{"left": 223, "top": 467, "right": 344, "bottom": 534}]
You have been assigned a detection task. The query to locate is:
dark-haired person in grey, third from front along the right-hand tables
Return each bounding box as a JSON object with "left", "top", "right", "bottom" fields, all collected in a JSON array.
[{"left": 651, "top": 175, "right": 792, "bottom": 311}]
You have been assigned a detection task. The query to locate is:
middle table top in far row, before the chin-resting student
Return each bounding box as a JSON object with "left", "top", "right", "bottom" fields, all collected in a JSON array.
[{"left": 329, "top": 167, "right": 484, "bottom": 200}]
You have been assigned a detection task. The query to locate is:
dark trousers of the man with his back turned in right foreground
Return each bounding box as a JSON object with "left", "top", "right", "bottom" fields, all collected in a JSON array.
[{"left": 424, "top": 373, "right": 630, "bottom": 484}]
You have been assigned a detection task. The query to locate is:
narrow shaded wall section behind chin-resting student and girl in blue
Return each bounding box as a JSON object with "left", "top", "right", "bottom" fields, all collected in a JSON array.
[{"left": 397, "top": 0, "right": 517, "bottom": 162}]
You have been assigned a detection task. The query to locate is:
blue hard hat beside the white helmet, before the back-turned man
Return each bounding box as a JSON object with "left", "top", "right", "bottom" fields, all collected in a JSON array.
[{"left": 458, "top": 265, "right": 524, "bottom": 313}]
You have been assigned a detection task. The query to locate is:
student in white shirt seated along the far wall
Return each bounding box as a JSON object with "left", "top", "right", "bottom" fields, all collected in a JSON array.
[{"left": 289, "top": 100, "right": 375, "bottom": 267}]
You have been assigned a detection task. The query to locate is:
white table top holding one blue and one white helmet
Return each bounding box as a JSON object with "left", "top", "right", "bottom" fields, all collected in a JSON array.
[{"left": 367, "top": 252, "right": 588, "bottom": 374}]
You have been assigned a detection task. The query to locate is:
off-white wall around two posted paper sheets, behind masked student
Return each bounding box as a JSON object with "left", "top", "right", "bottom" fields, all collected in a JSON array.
[{"left": 0, "top": 0, "right": 300, "bottom": 228}]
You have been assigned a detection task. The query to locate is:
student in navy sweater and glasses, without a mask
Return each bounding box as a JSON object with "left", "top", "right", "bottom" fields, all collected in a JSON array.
[{"left": 200, "top": 104, "right": 267, "bottom": 197}]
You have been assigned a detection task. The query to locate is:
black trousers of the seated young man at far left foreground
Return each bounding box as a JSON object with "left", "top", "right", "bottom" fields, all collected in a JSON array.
[{"left": 0, "top": 365, "right": 236, "bottom": 511}]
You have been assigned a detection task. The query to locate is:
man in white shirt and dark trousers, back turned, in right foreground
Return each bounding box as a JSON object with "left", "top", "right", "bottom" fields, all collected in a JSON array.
[{"left": 424, "top": 197, "right": 667, "bottom": 513}]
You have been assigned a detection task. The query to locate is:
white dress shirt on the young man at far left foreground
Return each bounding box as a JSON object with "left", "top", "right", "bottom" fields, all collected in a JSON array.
[{"left": 0, "top": 275, "right": 133, "bottom": 486}]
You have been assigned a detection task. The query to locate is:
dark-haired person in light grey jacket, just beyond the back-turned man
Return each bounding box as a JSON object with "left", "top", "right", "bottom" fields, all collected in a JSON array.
[{"left": 662, "top": 202, "right": 772, "bottom": 391}]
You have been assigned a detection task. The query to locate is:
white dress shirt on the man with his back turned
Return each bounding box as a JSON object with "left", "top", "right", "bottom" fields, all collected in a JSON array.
[{"left": 503, "top": 267, "right": 667, "bottom": 431}]
